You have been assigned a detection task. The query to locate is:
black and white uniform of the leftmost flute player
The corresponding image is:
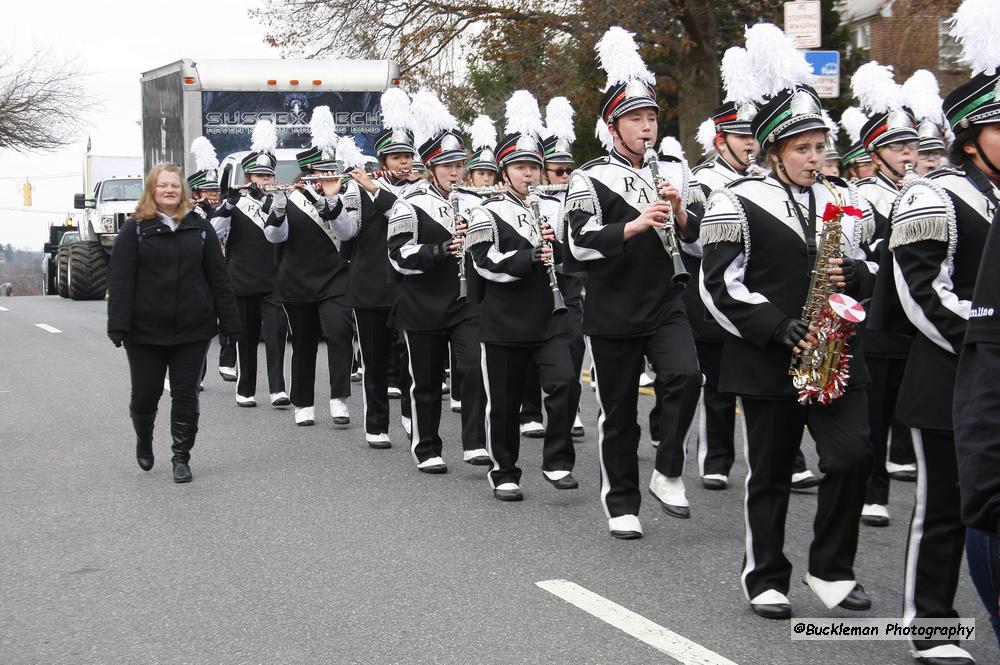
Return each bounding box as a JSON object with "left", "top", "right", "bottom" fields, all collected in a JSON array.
[{"left": 212, "top": 192, "right": 288, "bottom": 397}]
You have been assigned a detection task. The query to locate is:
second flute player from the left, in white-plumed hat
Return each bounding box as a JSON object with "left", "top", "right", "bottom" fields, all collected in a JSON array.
[{"left": 264, "top": 106, "right": 364, "bottom": 426}]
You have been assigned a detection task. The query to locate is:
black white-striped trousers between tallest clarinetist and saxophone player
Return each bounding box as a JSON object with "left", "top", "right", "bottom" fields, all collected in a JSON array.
[{"left": 694, "top": 340, "right": 736, "bottom": 476}]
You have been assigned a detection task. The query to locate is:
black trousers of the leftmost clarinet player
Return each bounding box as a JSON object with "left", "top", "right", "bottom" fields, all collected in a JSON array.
[{"left": 403, "top": 318, "right": 486, "bottom": 464}]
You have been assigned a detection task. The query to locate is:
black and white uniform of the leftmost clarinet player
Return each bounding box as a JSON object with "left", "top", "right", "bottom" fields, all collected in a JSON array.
[{"left": 387, "top": 182, "right": 485, "bottom": 464}]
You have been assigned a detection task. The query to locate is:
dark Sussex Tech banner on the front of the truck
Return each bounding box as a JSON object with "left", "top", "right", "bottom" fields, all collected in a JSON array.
[{"left": 202, "top": 92, "right": 382, "bottom": 157}]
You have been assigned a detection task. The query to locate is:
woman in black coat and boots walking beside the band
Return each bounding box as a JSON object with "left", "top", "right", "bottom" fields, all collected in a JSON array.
[{"left": 108, "top": 164, "right": 240, "bottom": 483}]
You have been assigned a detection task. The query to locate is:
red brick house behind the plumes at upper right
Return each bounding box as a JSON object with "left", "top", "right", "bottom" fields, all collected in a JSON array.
[{"left": 838, "top": 0, "right": 969, "bottom": 96}]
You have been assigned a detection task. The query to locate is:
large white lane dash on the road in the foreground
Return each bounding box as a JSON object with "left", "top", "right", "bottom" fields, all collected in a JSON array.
[{"left": 535, "top": 580, "right": 736, "bottom": 665}]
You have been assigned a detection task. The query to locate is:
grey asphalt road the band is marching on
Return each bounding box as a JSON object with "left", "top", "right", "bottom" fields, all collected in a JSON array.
[{"left": 0, "top": 297, "right": 1000, "bottom": 665}]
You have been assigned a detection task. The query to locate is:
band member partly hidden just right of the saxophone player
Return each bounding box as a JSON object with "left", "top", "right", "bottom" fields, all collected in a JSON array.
[{"left": 851, "top": 62, "right": 918, "bottom": 526}]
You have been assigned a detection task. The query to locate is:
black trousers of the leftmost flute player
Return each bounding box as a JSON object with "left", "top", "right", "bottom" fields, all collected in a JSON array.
[{"left": 236, "top": 293, "right": 288, "bottom": 397}]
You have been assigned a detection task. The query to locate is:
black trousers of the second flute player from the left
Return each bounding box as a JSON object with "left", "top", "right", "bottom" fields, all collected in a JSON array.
[{"left": 285, "top": 300, "right": 353, "bottom": 408}]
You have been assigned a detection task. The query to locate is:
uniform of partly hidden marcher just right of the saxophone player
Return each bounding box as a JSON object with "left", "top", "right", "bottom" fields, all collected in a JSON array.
[{"left": 855, "top": 173, "right": 914, "bottom": 498}]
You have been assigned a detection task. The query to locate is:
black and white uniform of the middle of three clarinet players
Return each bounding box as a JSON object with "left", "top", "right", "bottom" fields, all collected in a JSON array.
[{"left": 463, "top": 192, "right": 579, "bottom": 489}]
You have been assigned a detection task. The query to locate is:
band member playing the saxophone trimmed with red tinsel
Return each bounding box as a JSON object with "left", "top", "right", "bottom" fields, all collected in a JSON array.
[{"left": 701, "top": 24, "right": 872, "bottom": 619}]
